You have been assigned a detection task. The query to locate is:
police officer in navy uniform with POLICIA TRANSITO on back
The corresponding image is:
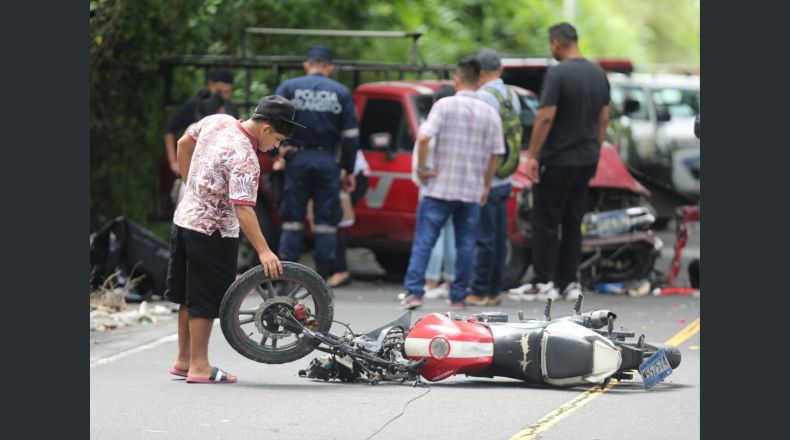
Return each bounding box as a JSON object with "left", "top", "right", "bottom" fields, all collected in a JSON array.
[{"left": 275, "top": 46, "right": 359, "bottom": 278}]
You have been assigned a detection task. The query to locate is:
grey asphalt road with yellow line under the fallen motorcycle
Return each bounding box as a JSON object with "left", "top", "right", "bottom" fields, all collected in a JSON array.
[{"left": 90, "top": 222, "right": 701, "bottom": 440}]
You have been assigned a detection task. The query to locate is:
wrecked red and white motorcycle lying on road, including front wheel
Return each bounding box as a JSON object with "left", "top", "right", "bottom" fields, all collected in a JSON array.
[{"left": 220, "top": 262, "right": 681, "bottom": 388}]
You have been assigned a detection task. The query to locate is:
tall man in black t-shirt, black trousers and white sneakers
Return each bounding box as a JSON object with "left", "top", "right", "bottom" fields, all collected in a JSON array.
[{"left": 508, "top": 23, "right": 609, "bottom": 301}]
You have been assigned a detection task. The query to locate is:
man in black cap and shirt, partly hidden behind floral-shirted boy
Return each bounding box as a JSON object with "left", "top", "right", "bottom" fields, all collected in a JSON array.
[{"left": 165, "top": 69, "right": 239, "bottom": 177}]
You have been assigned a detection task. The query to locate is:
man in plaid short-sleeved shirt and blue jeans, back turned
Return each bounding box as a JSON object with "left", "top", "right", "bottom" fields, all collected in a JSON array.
[{"left": 402, "top": 58, "right": 505, "bottom": 309}]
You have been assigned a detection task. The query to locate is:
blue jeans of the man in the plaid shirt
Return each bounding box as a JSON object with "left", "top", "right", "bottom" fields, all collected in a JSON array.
[{"left": 403, "top": 197, "right": 480, "bottom": 302}]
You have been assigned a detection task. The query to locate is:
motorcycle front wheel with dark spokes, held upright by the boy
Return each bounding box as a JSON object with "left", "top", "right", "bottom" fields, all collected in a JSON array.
[{"left": 219, "top": 261, "right": 334, "bottom": 364}]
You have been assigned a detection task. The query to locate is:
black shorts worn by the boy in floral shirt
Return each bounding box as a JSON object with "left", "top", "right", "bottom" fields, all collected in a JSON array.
[{"left": 165, "top": 224, "right": 239, "bottom": 319}]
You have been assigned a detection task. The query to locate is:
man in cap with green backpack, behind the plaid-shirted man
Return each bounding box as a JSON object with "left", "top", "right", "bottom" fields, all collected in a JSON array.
[{"left": 466, "top": 49, "right": 523, "bottom": 306}]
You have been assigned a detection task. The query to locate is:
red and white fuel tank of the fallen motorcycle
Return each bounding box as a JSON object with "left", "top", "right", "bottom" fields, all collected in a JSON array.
[{"left": 405, "top": 313, "right": 494, "bottom": 382}]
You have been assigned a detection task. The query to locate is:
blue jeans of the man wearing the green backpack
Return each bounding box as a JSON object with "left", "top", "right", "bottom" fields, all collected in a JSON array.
[{"left": 471, "top": 184, "right": 510, "bottom": 297}]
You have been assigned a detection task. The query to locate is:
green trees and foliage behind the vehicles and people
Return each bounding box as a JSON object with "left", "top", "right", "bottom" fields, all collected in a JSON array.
[{"left": 90, "top": 0, "right": 700, "bottom": 230}]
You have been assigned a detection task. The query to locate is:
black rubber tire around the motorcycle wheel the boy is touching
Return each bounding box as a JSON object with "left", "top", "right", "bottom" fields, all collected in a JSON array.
[{"left": 219, "top": 261, "right": 334, "bottom": 364}]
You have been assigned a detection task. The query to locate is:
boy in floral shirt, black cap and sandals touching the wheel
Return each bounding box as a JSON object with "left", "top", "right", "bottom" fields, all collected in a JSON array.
[{"left": 165, "top": 96, "right": 304, "bottom": 383}]
